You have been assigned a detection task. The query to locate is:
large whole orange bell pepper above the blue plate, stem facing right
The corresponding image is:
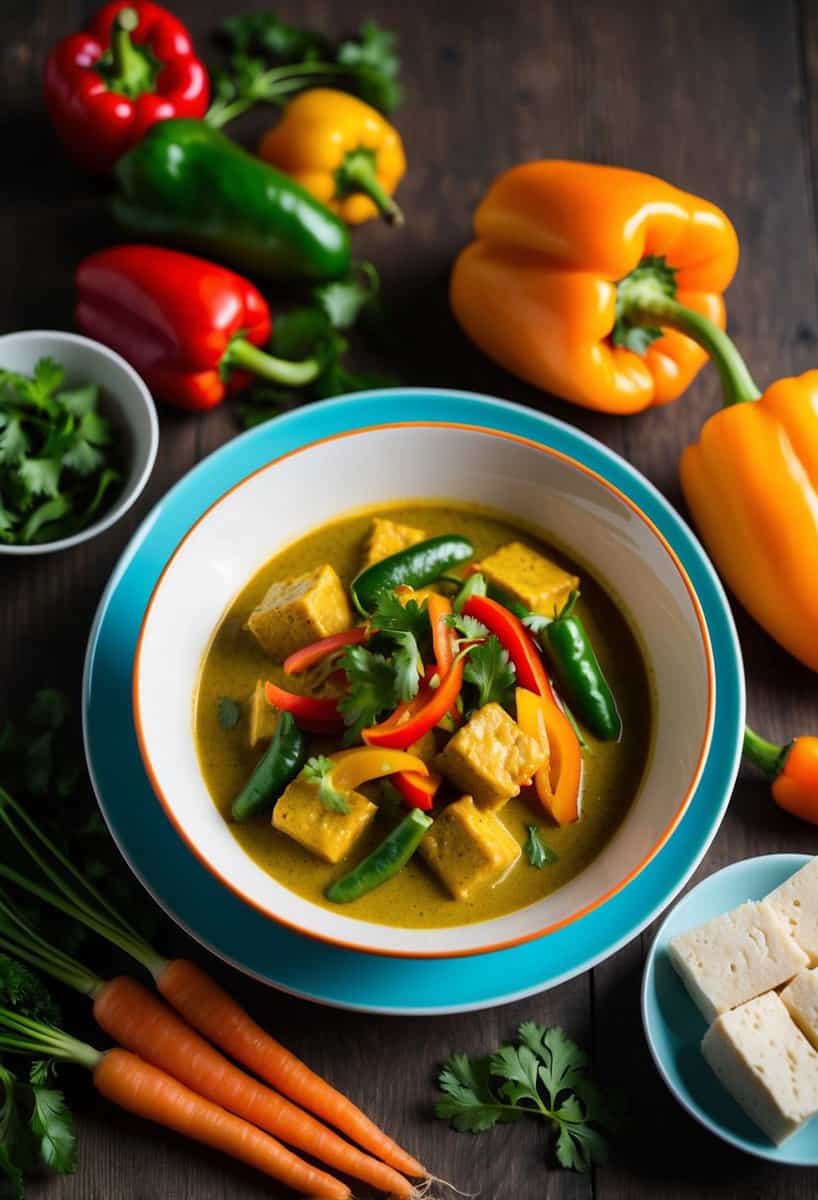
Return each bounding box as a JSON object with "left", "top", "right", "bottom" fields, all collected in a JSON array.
[{"left": 450, "top": 161, "right": 739, "bottom": 413}]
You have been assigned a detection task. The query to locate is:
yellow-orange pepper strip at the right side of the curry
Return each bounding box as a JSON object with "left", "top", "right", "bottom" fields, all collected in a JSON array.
[{"left": 516, "top": 688, "right": 582, "bottom": 824}]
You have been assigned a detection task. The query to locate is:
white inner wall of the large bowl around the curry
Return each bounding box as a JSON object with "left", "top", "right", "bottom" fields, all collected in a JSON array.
[{"left": 134, "top": 426, "right": 714, "bottom": 955}]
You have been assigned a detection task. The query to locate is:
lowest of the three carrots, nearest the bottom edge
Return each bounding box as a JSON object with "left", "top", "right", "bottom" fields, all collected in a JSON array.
[{"left": 94, "top": 1049, "right": 351, "bottom": 1200}]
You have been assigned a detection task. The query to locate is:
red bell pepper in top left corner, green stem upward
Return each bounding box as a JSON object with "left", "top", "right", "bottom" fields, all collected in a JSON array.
[{"left": 44, "top": 0, "right": 210, "bottom": 173}]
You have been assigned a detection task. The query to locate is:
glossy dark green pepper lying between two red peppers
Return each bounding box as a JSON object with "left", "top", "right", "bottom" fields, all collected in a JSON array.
[{"left": 113, "top": 118, "right": 350, "bottom": 280}]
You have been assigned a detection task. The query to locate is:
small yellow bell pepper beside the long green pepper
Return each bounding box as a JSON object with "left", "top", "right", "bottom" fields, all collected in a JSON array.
[{"left": 258, "top": 88, "right": 407, "bottom": 224}]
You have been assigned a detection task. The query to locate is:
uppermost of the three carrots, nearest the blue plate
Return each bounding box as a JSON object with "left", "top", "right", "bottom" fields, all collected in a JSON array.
[{"left": 155, "top": 959, "right": 428, "bottom": 1178}]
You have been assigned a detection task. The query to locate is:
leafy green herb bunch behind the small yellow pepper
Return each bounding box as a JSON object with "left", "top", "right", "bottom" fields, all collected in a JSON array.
[{"left": 206, "top": 12, "right": 402, "bottom": 127}]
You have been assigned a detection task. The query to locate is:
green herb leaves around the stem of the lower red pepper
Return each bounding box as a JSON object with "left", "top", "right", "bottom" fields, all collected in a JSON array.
[{"left": 239, "top": 263, "right": 395, "bottom": 428}]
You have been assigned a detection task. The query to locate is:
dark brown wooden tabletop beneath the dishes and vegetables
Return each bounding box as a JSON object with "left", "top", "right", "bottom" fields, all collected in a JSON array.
[{"left": 0, "top": 0, "right": 818, "bottom": 1200}]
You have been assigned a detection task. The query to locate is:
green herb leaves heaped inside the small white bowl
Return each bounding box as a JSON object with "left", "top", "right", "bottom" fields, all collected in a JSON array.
[{"left": 0, "top": 358, "right": 121, "bottom": 545}]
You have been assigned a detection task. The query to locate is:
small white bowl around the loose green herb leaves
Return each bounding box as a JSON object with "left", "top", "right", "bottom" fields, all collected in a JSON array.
[{"left": 0, "top": 329, "right": 160, "bottom": 554}]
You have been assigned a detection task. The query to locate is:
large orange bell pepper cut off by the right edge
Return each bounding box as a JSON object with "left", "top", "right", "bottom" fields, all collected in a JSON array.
[{"left": 680, "top": 364, "right": 818, "bottom": 671}]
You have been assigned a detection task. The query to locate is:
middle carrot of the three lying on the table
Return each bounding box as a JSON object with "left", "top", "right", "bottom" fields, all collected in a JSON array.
[{"left": 94, "top": 976, "right": 414, "bottom": 1198}]
